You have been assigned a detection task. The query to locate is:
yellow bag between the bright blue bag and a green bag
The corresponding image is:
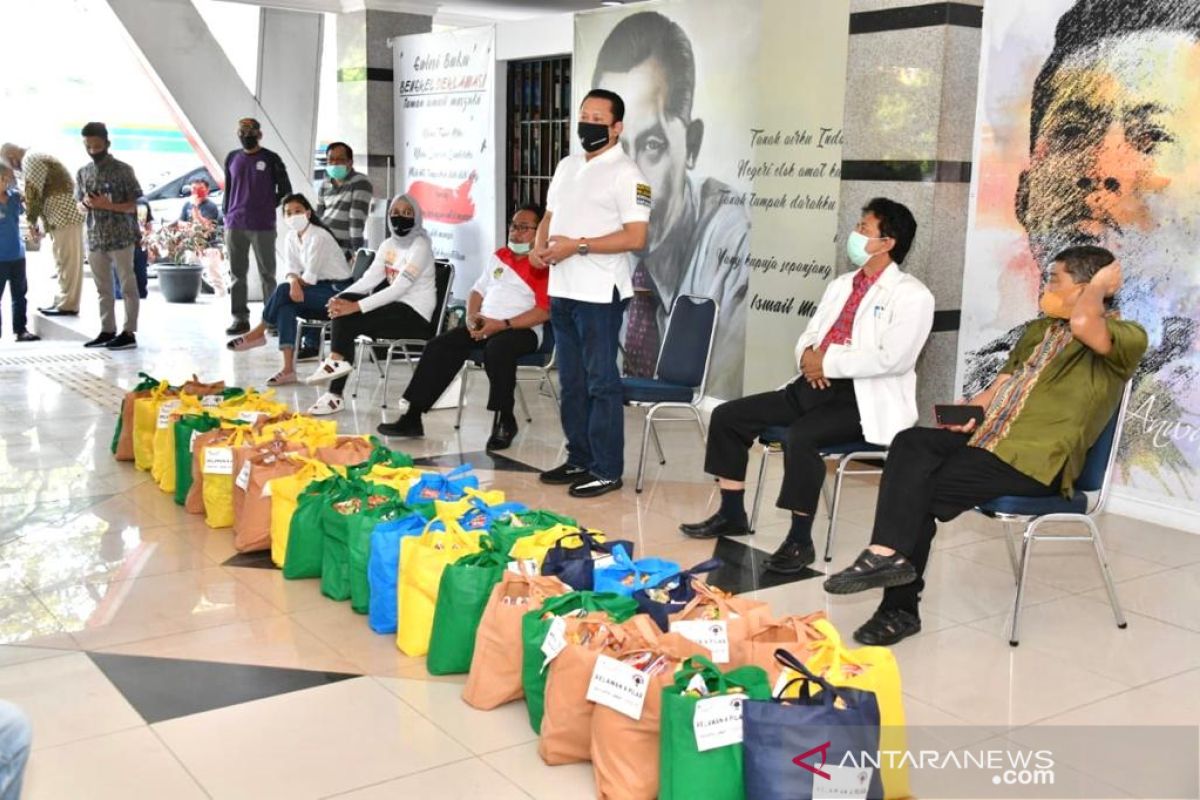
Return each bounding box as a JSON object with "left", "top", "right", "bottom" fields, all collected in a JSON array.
[{"left": 396, "top": 518, "right": 480, "bottom": 657}]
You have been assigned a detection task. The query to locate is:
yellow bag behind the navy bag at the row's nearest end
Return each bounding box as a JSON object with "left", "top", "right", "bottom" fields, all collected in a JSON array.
[{"left": 776, "top": 619, "right": 912, "bottom": 800}]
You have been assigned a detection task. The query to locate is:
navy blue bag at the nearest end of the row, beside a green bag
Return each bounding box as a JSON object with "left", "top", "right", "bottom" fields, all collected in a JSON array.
[{"left": 742, "top": 650, "right": 883, "bottom": 800}]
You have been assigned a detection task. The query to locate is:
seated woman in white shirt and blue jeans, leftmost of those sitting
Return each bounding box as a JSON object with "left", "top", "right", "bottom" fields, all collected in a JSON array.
[{"left": 226, "top": 194, "right": 350, "bottom": 386}]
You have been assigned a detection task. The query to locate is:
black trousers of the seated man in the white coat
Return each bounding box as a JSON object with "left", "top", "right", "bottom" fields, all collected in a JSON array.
[{"left": 704, "top": 379, "right": 863, "bottom": 515}]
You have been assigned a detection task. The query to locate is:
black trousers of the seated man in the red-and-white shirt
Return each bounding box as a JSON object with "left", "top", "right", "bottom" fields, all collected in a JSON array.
[{"left": 404, "top": 326, "right": 538, "bottom": 414}]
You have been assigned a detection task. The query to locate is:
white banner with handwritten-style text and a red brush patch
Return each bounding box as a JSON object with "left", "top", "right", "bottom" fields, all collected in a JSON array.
[{"left": 392, "top": 26, "right": 497, "bottom": 299}]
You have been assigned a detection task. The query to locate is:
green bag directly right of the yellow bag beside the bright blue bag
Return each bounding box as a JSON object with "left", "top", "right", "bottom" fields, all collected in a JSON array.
[{"left": 425, "top": 536, "right": 509, "bottom": 675}]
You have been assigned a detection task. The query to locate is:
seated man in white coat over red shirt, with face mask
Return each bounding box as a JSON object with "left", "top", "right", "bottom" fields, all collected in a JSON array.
[{"left": 679, "top": 198, "right": 934, "bottom": 575}]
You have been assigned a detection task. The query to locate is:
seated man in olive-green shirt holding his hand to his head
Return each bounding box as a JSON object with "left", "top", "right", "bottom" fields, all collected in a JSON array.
[{"left": 824, "top": 245, "right": 1147, "bottom": 645}]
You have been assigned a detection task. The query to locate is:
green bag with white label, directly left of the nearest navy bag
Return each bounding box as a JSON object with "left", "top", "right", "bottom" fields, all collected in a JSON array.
[{"left": 659, "top": 656, "right": 770, "bottom": 800}]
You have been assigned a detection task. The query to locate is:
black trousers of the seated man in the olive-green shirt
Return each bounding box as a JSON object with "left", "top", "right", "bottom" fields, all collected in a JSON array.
[{"left": 871, "top": 428, "right": 1060, "bottom": 613}]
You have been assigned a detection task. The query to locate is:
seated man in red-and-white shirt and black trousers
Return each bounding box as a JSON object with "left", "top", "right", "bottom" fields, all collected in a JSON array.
[{"left": 377, "top": 205, "right": 550, "bottom": 450}]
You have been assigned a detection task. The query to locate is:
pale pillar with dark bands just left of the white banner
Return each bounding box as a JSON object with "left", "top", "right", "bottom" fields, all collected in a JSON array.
[{"left": 337, "top": 8, "right": 433, "bottom": 198}]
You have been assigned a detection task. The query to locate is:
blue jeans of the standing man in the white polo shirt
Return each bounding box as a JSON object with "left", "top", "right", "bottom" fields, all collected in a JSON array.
[{"left": 550, "top": 289, "right": 629, "bottom": 481}]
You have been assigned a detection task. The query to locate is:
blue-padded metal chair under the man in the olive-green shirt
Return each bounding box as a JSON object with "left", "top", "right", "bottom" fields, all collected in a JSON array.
[{"left": 976, "top": 384, "right": 1130, "bottom": 648}]
